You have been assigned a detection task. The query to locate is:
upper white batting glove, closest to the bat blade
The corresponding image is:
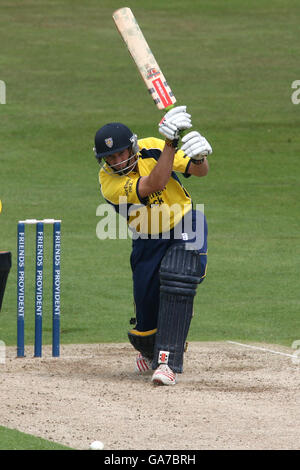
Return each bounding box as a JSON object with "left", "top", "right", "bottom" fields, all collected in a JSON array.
[{"left": 158, "top": 106, "right": 192, "bottom": 140}]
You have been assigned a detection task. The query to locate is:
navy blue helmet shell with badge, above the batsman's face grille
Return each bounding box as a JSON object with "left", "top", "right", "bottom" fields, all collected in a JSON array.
[{"left": 94, "top": 122, "right": 138, "bottom": 160}]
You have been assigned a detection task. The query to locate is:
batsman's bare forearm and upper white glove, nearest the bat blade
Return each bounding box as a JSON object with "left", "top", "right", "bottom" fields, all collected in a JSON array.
[{"left": 138, "top": 106, "right": 192, "bottom": 198}]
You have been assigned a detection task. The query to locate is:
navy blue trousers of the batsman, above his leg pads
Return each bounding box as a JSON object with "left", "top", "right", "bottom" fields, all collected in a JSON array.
[{"left": 130, "top": 210, "right": 207, "bottom": 331}]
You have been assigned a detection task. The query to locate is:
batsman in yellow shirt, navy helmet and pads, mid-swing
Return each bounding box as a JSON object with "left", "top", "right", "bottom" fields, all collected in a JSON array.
[{"left": 94, "top": 106, "right": 212, "bottom": 385}]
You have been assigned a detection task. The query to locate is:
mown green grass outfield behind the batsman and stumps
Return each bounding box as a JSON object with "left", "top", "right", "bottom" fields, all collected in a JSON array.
[{"left": 0, "top": 0, "right": 300, "bottom": 352}]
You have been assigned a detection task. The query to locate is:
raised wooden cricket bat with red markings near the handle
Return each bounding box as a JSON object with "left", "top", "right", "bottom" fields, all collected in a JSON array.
[{"left": 113, "top": 7, "right": 176, "bottom": 111}]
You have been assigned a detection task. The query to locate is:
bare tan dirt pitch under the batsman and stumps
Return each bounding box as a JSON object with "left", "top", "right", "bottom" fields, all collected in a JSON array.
[{"left": 0, "top": 342, "right": 300, "bottom": 450}]
